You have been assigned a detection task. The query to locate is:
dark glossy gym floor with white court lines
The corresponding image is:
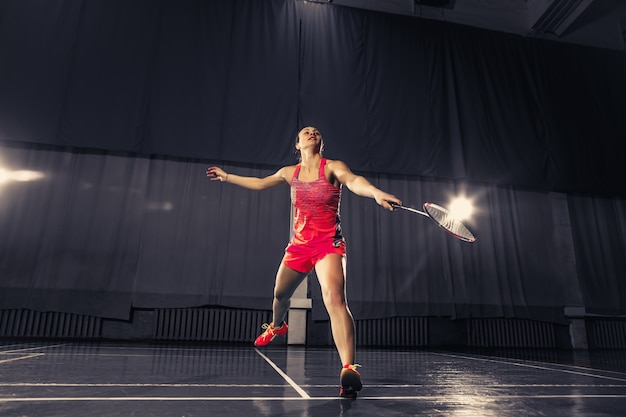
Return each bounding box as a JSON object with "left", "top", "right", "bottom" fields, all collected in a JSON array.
[{"left": 0, "top": 340, "right": 626, "bottom": 417}]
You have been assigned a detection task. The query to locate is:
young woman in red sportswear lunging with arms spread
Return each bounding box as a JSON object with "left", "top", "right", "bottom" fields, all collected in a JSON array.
[{"left": 206, "top": 126, "right": 401, "bottom": 398}]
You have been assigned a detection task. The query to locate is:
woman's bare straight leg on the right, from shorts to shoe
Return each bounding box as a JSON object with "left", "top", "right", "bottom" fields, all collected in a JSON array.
[{"left": 315, "top": 254, "right": 355, "bottom": 365}]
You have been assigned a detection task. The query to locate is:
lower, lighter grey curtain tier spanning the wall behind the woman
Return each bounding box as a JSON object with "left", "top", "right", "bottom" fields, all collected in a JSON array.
[{"left": 0, "top": 144, "right": 626, "bottom": 321}]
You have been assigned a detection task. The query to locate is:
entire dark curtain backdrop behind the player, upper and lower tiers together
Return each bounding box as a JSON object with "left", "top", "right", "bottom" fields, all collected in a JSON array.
[{"left": 0, "top": 0, "right": 626, "bottom": 320}]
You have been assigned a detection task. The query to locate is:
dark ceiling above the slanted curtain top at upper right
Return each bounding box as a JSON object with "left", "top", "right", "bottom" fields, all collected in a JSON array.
[{"left": 322, "top": 0, "right": 626, "bottom": 50}]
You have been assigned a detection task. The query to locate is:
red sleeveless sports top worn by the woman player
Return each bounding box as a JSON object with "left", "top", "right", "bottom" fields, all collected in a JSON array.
[{"left": 291, "top": 158, "right": 343, "bottom": 247}]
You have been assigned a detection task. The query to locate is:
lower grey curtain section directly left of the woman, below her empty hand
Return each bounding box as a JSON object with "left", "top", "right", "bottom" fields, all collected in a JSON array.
[{"left": 133, "top": 160, "right": 290, "bottom": 309}]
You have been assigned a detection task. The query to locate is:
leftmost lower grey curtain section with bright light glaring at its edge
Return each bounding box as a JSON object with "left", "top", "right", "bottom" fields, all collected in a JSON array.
[{"left": 0, "top": 146, "right": 141, "bottom": 317}]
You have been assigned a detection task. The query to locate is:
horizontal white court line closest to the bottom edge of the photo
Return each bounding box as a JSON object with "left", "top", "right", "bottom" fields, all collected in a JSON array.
[{"left": 0, "top": 394, "right": 626, "bottom": 404}]
